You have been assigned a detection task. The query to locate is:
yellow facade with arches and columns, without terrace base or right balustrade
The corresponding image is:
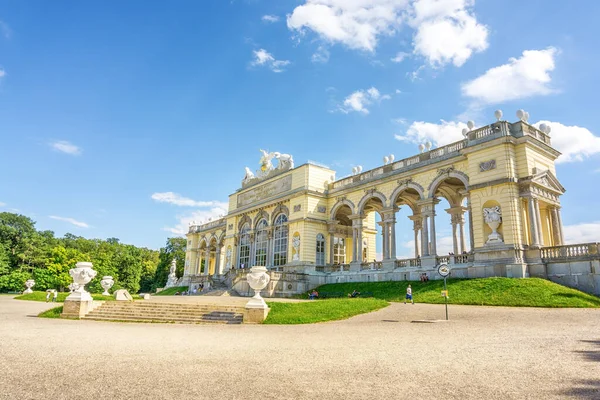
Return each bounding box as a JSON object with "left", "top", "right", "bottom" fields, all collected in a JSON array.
[{"left": 185, "top": 121, "right": 564, "bottom": 276}]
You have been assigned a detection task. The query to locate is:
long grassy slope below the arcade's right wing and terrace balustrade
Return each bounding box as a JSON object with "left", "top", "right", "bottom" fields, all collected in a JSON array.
[{"left": 304, "top": 278, "right": 600, "bottom": 308}]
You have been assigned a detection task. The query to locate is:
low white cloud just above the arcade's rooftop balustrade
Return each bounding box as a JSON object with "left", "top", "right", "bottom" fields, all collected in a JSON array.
[{"left": 394, "top": 120, "right": 467, "bottom": 146}]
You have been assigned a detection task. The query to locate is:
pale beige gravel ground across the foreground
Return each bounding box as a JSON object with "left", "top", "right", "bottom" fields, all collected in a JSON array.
[{"left": 0, "top": 296, "right": 600, "bottom": 400}]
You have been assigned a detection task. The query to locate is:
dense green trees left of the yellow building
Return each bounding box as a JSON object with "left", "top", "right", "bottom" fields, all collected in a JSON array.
[{"left": 0, "top": 212, "right": 173, "bottom": 296}]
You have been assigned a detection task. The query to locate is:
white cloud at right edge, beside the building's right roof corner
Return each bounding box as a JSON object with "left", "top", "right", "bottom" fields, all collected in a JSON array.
[{"left": 534, "top": 121, "right": 600, "bottom": 163}]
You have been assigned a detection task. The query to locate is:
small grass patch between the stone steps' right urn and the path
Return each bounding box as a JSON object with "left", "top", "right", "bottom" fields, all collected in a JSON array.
[{"left": 264, "top": 298, "right": 388, "bottom": 324}]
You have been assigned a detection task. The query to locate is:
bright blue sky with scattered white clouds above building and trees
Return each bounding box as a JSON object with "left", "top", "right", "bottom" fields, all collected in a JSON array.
[{"left": 0, "top": 0, "right": 600, "bottom": 253}]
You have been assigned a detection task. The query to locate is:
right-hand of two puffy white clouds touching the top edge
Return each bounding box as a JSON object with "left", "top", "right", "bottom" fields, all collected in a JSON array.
[{"left": 408, "top": 0, "right": 488, "bottom": 67}]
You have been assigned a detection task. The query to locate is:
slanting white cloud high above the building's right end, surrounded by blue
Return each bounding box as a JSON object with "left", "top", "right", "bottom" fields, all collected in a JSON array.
[{"left": 461, "top": 47, "right": 558, "bottom": 104}]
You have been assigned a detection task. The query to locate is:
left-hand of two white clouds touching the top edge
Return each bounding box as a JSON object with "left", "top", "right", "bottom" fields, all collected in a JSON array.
[{"left": 287, "top": 0, "right": 408, "bottom": 52}]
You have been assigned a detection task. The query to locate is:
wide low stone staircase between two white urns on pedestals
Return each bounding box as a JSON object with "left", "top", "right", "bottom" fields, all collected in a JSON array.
[{"left": 83, "top": 301, "right": 245, "bottom": 324}]
